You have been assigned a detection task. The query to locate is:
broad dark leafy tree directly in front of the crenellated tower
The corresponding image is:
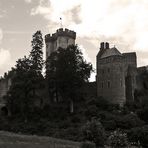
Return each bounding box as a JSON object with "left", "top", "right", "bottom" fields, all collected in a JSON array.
[{"left": 46, "top": 45, "right": 92, "bottom": 112}]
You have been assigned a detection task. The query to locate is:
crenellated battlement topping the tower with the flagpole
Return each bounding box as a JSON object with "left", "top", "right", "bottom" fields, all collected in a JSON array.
[{"left": 45, "top": 28, "right": 76, "bottom": 42}]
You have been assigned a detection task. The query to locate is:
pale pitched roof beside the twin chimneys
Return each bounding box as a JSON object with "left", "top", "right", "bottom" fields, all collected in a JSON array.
[{"left": 101, "top": 47, "right": 122, "bottom": 58}]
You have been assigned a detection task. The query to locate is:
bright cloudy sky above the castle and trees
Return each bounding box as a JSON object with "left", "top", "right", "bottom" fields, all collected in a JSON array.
[{"left": 0, "top": 0, "right": 148, "bottom": 80}]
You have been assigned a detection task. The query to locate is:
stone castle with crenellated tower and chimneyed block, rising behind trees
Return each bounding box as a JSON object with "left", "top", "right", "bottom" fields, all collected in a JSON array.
[{"left": 0, "top": 28, "right": 147, "bottom": 106}]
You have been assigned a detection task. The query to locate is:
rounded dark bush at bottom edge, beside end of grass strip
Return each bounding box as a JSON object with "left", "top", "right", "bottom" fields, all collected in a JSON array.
[{"left": 82, "top": 119, "right": 106, "bottom": 146}]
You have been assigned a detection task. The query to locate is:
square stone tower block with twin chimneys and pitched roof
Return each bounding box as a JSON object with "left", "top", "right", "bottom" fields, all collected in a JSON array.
[{"left": 96, "top": 42, "right": 137, "bottom": 106}]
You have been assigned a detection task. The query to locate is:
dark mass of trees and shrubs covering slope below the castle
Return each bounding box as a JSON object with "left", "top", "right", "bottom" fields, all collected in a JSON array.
[{"left": 0, "top": 31, "right": 148, "bottom": 148}]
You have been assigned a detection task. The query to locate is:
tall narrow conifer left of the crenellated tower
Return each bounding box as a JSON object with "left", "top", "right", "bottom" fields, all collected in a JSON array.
[{"left": 29, "top": 31, "right": 44, "bottom": 101}]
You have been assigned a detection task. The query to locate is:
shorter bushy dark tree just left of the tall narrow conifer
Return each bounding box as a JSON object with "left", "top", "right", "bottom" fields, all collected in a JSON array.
[{"left": 6, "top": 57, "right": 31, "bottom": 117}]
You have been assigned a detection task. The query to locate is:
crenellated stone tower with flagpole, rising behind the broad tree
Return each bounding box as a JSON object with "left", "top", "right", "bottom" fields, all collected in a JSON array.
[{"left": 45, "top": 28, "right": 76, "bottom": 59}]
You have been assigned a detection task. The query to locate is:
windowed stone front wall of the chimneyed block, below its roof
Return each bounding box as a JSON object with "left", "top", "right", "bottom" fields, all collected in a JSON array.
[{"left": 97, "top": 56, "right": 126, "bottom": 105}]
